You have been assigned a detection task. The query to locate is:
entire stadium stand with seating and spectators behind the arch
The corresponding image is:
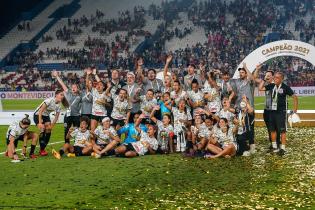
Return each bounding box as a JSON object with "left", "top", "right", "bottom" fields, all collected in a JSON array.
[{"left": 0, "top": 0, "right": 315, "bottom": 90}]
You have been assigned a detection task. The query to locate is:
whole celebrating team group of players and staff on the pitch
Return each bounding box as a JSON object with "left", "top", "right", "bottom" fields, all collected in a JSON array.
[{"left": 6, "top": 55, "right": 298, "bottom": 160}]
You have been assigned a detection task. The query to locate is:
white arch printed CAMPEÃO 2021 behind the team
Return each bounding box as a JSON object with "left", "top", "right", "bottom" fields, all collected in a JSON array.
[{"left": 233, "top": 40, "right": 315, "bottom": 78}]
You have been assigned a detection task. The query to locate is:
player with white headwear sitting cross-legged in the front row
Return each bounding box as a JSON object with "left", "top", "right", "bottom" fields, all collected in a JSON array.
[{"left": 91, "top": 117, "right": 120, "bottom": 158}]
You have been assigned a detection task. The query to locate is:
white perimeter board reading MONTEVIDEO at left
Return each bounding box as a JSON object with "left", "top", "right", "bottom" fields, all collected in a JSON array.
[{"left": 0, "top": 91, "right": 55, "bottom": 99}]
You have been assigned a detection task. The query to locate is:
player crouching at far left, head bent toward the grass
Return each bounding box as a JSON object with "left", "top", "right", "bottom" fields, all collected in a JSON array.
[{"left": 6, "top": 114, "right": 38, "bottom": 160}]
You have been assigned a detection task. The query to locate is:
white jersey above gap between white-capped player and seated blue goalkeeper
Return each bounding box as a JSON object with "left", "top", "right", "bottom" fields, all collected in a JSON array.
[{"left": 111, "top": 95, "right": 132, "bottom": 120}]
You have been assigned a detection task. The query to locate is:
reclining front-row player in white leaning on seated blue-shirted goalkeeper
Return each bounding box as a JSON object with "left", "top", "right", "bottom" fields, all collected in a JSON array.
[{"left": 115, "top": 114, "right": 159, "bottom": 157}]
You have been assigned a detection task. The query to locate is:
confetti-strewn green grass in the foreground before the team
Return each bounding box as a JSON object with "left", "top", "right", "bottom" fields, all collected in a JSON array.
[{"left": 0, "top": 125, "right": 315, "bottom": 209}]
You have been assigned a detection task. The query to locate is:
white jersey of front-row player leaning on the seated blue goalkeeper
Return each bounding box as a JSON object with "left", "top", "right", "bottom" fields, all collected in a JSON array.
[{"left": 131, "top": 131, "right": 159, "bottom": 155}]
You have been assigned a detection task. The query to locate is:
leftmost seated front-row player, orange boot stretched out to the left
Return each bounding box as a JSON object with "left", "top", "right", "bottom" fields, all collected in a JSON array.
[{"left": 52, "top": 117, "right": 92, "bottom": 159}]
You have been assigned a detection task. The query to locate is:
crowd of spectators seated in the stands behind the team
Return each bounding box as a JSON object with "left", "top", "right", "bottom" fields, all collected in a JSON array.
[{"left": 1, "top": 0, "right": 315, "bottom": 90}]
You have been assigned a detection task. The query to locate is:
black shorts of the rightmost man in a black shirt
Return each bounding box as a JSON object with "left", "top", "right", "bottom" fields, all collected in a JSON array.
[{"left": 268, "top": 111, "right": 287, "bottom": 133}]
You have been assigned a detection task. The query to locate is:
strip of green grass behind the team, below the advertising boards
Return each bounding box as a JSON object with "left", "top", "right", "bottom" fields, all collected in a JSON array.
[{"left": 2, "top": 96, "right": 315, "bottom": 111}]
